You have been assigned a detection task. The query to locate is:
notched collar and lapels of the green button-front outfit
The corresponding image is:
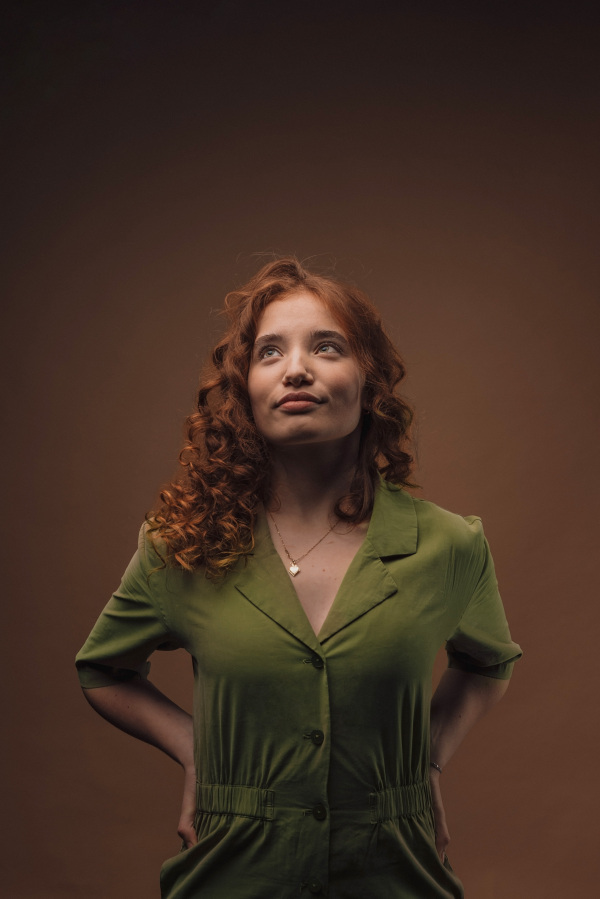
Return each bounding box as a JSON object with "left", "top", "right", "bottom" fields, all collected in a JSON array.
[{"left": 233, "top": 480, "right": 418, "bottom": 653}]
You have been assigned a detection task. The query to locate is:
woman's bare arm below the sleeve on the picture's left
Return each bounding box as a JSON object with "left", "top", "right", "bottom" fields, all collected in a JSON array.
[{"left": 83, "top": 678, "right": 197, "bottom": 848}]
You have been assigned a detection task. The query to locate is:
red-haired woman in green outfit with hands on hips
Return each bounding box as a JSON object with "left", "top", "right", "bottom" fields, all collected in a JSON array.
[{"left": 77, "top": 258, "right": 520, "bottom": 899}]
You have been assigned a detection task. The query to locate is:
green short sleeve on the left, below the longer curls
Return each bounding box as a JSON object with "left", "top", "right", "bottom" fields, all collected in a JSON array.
[{"left": 75, "top": 524, "right": 179, "bottom": 688}]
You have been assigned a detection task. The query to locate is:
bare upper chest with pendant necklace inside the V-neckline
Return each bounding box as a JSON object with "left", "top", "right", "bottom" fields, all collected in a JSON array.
[{"left": 269, "top": 518, "right": 369, "bottom": 634}]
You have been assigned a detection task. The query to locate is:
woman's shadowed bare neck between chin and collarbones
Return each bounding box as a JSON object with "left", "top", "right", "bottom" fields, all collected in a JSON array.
[{"left": 270, "top": 440, "right": 358, "bottom": 522}]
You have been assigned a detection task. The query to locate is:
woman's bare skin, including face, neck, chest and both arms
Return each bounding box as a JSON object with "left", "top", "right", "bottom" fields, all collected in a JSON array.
[{"left": 84, "top": 292, "right": 507, "bottom": 859}]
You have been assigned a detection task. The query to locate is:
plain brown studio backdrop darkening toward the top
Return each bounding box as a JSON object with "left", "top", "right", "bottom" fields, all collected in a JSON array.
[{"left": 2, "top": 0, "right": 600, "bottom": 899}]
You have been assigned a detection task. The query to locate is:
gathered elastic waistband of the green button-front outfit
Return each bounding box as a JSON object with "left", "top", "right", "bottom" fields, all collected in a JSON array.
[{"left": 196, "top": 781, "right": 431, "bottom": 824}]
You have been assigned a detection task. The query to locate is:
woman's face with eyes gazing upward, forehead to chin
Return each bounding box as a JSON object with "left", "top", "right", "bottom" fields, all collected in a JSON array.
[{"left": 248, "top": 291, "right": 365, "bottom": 446}]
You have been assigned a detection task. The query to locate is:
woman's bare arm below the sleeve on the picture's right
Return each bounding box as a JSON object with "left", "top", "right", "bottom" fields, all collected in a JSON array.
[{"left": 430, "top": 668, "right": 508, "bottom": 861}]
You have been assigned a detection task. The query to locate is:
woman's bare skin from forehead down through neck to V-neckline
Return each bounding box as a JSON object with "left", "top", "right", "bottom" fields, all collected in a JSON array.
[{"left": 248, "top": 291, "right": 368, "bottom": 633}]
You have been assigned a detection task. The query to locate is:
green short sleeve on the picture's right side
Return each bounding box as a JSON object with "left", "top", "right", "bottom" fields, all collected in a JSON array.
[{"left": 446, "top": 517, "right": 522, "bottom": 680}]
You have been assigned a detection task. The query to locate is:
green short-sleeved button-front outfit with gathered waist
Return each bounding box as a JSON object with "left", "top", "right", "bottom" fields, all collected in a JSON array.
[{"left": 77, "top": 481, "right": 521, "bottom": 899}]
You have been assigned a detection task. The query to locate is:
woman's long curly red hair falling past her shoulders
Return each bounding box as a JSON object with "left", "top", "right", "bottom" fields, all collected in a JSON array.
[{"left": 148, "top": 257, "right": 414, "bottom": 577}]
